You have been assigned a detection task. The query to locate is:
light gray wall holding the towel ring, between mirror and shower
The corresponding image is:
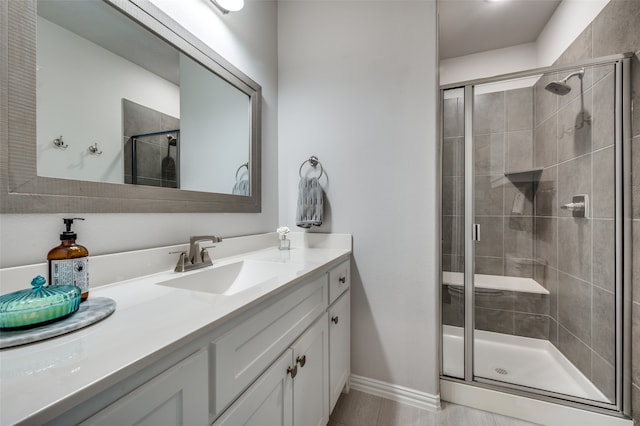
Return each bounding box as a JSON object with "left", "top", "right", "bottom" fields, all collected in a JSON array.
[{"left": 278, "top": 0, "right": 439, "bottom": 395}]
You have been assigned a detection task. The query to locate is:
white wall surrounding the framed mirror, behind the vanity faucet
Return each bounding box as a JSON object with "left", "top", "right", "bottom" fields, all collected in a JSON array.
[{"left": 0, "top": 0, "right": 278, "bottom": 268}]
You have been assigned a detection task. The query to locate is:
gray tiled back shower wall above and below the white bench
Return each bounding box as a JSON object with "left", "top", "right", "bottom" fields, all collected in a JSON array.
[{"left": 442, "top": 88, "right": 549, "bottom": 339}]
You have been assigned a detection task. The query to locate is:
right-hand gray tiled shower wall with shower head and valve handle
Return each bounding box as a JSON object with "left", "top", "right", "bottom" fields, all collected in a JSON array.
[{"left": 533, "top": 0, "right": 640, "bottom": 406}]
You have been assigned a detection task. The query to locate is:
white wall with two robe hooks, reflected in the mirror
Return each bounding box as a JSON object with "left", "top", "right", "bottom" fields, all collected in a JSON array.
[{"left": 36, "top": 17, "right": 180, "bottom": 183}]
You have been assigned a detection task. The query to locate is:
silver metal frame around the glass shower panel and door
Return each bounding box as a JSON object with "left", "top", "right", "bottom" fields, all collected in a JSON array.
[{"left": 439, "top": 53, "right": 633, "bottom": 416}]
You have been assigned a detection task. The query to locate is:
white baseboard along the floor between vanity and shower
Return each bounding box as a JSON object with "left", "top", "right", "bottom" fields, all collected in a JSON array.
[{"left": 350, "top": 374, "right": 440, "bottom": 411}]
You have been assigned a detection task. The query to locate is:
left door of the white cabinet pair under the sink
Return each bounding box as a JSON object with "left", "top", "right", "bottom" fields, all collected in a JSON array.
[{"left": 214, "top": 349, "right": 299, "bottom": 426}]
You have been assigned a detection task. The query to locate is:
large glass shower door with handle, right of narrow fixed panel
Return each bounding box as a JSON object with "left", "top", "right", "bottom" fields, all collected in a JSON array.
[{"left": 472, "top": 64, "right": 616, "bottom": 403}]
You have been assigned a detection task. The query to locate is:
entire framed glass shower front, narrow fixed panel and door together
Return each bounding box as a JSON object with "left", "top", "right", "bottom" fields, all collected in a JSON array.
[{"left": 442, "top": 56, "right": 628, "bottom": 409}]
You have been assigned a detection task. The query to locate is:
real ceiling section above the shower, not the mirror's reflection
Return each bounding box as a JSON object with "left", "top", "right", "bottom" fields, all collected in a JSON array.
[{"left": 438, "top": 0, "right": 561, "bottom": 59}]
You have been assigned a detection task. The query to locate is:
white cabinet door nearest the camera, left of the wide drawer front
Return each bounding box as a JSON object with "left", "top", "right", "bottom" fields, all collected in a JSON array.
[{"left": 82, "top": 351, "right": 209, "bottom": 426}]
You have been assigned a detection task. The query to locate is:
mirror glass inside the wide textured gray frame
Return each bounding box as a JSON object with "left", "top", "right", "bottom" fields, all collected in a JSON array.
[{"left": 36, "top": 0, "right": 251, "bottom": 195}]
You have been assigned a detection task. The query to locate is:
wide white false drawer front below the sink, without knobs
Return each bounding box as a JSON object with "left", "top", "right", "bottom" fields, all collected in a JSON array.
[{"left": 209, "top": 274, "right": 327, "bottom": 416}]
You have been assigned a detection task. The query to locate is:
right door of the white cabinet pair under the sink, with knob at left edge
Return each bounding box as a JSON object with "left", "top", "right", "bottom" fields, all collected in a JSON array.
[{"left": 292, "top": 313, "right": 329, "bottom": 426}]
